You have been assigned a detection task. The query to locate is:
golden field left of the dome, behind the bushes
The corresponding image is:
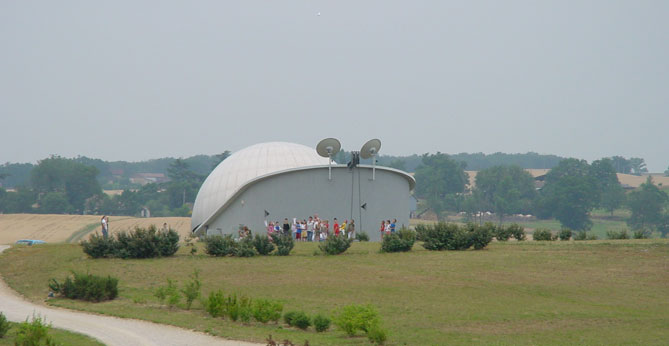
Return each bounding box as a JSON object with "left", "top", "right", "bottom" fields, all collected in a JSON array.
[{"left": 0, "top": 214, "right": 190, "bottom": 244}]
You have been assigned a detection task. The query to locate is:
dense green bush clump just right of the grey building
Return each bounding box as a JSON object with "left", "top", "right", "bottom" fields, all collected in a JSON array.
[{"left": 416, "top": 222, "right": 493, "bottom": 251}]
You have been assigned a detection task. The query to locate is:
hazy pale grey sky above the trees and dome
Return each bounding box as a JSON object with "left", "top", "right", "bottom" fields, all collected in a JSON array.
[{"left": 0, "top": 0, "right": 669, "bottom": 171}]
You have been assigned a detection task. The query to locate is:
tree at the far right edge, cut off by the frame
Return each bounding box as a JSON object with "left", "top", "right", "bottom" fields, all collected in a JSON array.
[{"left": 627, "top": 176, "right": 669, "bottom": 234}]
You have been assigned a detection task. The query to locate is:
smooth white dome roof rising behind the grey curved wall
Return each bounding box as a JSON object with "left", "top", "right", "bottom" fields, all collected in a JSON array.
[{"left": 191, "top": 142, "right": 328, "bottom": 229}]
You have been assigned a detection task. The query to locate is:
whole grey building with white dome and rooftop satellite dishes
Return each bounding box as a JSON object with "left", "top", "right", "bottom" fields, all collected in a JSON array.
[{"left": 191, "top": 139, "right": 415, "bottom": 240}]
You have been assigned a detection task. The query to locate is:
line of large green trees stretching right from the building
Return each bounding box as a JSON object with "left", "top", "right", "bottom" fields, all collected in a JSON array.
[{"left": 415, "top": 153, "right": 669, "bottom": 235}]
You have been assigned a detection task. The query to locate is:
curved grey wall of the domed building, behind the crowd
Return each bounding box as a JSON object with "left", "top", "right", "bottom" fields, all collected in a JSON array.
[{"left": 207, "top": 167, "right": 410, "bottom": 241}]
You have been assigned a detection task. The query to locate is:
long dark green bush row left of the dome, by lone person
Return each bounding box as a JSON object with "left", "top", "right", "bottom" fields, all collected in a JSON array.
[{"left": 81, "top": 225, "right": 179, "bottom": 258}]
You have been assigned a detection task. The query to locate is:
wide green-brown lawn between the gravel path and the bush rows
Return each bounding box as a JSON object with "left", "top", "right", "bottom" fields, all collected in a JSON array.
[{"left": 0, "top": 239, "right": 669, "bottom": 345}]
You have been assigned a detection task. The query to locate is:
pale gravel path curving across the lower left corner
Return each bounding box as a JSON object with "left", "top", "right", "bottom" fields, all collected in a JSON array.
[{"left": 0, "top": 245, "right": 261, "bottom": 346}]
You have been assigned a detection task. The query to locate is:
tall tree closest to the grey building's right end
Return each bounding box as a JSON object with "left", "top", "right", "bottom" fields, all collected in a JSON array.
[{"left": 414, "top": 152, "right": 469, "bottom": 217}]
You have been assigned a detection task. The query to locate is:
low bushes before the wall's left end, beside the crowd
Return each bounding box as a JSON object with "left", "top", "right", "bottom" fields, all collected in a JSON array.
[{"left": 204, "top": 234, "right": 295, "bottom": 257}]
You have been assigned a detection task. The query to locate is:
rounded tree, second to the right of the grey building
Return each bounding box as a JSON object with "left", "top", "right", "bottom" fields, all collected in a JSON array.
[{"left": 475, "top": 166, "right": 536, "bottom": 224}]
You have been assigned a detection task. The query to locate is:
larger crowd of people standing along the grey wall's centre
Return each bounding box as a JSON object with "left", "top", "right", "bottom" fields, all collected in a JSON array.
[{"left": 265, "top": 215, "right": 355, "bottom": 241}]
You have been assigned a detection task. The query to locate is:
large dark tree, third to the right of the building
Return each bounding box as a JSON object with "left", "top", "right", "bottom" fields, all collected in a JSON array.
[{"left": 537, "top": 159, "right": 601, "bottom": 230}]
